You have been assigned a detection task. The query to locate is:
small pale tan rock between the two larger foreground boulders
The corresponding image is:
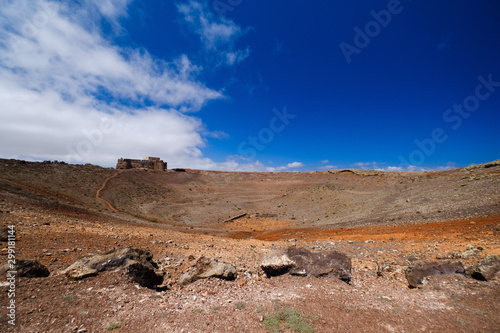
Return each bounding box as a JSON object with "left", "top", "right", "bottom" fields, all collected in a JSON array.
[{"left": 178, "top": 257, "right": 237, "bottom": 285}]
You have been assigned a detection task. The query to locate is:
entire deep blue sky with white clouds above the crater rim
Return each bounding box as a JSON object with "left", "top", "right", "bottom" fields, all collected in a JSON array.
[{"left": 0, "top": 0, "right": 500, "bottom": 171}]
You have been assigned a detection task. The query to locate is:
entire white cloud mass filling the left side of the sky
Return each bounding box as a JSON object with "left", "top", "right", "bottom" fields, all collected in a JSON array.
[{"left": 0, "top": 0, "right": 295, "bottom": 171}]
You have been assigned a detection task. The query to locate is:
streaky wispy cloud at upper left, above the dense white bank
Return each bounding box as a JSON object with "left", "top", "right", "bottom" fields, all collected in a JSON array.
[{"left": 0, "top": 0, "right": 223, "bottom": 111}]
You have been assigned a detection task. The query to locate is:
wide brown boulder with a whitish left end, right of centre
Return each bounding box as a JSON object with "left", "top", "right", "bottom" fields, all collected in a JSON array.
[{"left": 261, "top": 247, "right": 351, "bottom": 283}]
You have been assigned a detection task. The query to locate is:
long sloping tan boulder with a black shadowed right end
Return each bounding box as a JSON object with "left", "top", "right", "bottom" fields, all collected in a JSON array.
[{"left": 63, "top": 247, "right": 164, "bottom": 288}]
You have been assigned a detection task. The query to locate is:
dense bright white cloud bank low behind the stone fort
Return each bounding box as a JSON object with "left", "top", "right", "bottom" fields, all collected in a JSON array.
[{"left": 0, "top": 70, "right": 204, "bottom": 166}]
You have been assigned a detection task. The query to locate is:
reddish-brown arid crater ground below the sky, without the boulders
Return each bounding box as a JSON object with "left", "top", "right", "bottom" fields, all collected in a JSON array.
[{"left": 0, "top": 160, "right": 500, "bottom": 333}]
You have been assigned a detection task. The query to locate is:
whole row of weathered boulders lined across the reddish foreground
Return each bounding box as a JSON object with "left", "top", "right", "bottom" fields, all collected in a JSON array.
[{"left": 0, "top": 247, "right": 500, "bottom": 288}]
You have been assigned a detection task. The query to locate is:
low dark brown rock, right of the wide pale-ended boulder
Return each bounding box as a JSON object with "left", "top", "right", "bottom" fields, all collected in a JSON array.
[{"left": 405, "top": 261, "right": 465, "bottom": 288}]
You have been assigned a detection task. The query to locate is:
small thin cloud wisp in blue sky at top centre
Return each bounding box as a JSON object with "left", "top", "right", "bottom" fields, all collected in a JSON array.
[{"left": 177, "top": 0, "right": 250, "bottom": 66}]
